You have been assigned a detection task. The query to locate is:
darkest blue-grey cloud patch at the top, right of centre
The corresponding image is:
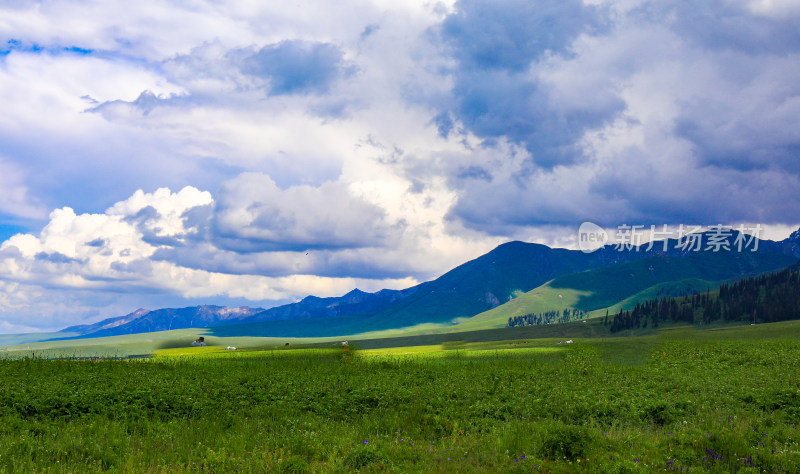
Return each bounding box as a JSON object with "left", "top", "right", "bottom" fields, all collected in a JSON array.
[{"left": 436, "top": 0, "right": 623, "bottom": 167}]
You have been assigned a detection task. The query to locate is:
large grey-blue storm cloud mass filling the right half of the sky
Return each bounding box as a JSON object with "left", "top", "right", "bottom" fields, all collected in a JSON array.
[{"left": 433, "top": 0, "right": 800, "bottom": 231}]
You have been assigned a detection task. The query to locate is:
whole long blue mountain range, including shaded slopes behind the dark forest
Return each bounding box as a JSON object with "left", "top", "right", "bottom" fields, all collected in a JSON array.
[{"left": 61, "top": 230, "right": 800, "bottom": 337}]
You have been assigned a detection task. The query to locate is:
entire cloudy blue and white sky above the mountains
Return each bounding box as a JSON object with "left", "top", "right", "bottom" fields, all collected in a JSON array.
[{"left": 0, "top": 0, "right": 800, "bottom": 333}]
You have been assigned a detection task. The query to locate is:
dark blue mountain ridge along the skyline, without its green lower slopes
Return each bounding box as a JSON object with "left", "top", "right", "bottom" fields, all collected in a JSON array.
[{"left": 56, "top": 230, "right": 800, "bottom": 337}]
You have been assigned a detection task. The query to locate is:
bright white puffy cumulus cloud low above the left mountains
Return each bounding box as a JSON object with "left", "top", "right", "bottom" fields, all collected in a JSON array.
[{"left": 0, "top": 187, "right": 413, "bottom": 301}]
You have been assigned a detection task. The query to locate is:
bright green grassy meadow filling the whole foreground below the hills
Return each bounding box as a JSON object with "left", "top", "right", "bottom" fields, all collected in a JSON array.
[{"left": 0, "top": 322, "right": 800, "bottom": 472}]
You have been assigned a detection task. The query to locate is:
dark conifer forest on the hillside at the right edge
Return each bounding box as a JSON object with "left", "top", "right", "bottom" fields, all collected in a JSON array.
[{"left": 603, "top": 266, "right": 800, "bottom": 332}]
